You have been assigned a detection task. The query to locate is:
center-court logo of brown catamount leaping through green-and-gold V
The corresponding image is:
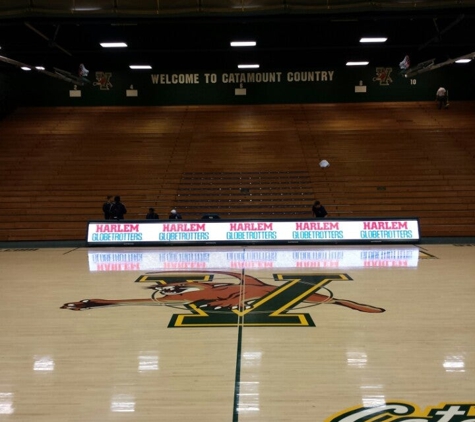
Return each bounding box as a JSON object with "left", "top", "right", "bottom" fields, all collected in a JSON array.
[{"left": 61, "top": 271, "right": 384, "bottom": 327}]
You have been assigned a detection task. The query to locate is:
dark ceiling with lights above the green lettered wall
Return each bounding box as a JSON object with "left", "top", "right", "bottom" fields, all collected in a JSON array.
[{"left": 0, "top": 0, "right": 475, "bottom": 72}]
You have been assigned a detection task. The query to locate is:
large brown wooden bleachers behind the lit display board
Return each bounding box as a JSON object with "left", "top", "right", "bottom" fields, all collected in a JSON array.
[{"left": 0, "top": 102, "right": 475, "bottom": 241}]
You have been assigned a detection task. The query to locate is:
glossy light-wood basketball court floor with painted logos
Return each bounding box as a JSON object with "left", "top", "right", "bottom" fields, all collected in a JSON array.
[{"left": 0, "top": 244, "right": 475, "bottom": 422}]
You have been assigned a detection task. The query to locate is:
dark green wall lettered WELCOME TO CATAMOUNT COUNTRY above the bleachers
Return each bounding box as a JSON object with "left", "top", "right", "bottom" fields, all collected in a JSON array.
[{"left": 8, "top": 63, "right": 475, "bottom": 106}]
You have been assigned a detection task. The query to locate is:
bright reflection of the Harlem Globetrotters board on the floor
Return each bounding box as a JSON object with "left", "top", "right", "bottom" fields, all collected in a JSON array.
[{"left": 88, "top": 245, "right": 420, "bottom": 271}]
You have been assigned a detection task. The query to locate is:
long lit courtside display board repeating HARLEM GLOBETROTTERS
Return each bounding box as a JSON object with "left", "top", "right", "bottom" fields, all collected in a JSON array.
[{"left": 87, "top": 218, "right": 419, "bottom": 246}]
